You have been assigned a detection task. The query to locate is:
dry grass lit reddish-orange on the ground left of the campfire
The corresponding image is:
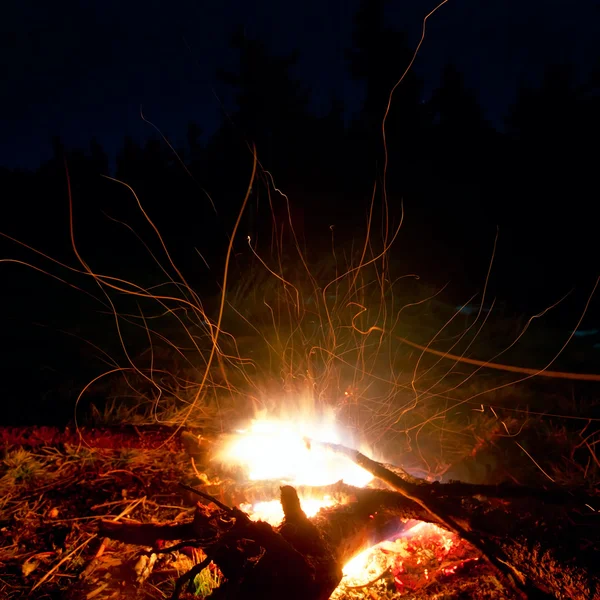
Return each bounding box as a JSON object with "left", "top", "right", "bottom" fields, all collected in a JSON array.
[{"left": 0, "top": 436, "right": 206, "bottom": 600}]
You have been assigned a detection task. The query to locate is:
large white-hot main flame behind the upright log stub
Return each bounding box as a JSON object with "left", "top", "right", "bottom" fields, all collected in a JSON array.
[{"left": 216, "top": 419, "right": 373, "bottom": 487}]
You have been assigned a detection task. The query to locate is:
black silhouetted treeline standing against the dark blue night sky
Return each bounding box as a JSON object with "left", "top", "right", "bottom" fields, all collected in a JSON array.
[{"left": 0, "top": 2, "right": 600, "bottom": 310}]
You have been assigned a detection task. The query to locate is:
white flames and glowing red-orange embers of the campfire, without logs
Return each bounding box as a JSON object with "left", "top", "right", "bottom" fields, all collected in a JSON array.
[{"left": 213, "top": 412, "right": 478, "bottom": 598}]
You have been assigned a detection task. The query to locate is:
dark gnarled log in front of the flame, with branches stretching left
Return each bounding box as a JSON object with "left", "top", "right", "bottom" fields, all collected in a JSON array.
[{"left": 101, "top": 486, "right": 342, "bottom": 600}]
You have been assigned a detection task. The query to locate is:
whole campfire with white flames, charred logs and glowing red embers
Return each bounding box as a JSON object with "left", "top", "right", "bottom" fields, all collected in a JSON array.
[{"left": 101, "top": 414, "right": 597, "bottom": 600}]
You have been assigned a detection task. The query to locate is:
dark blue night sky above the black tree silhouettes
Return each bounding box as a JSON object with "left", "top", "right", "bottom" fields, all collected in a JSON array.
[{"left": 0, "top": 0, "right": 600, "bottom": 167}]
